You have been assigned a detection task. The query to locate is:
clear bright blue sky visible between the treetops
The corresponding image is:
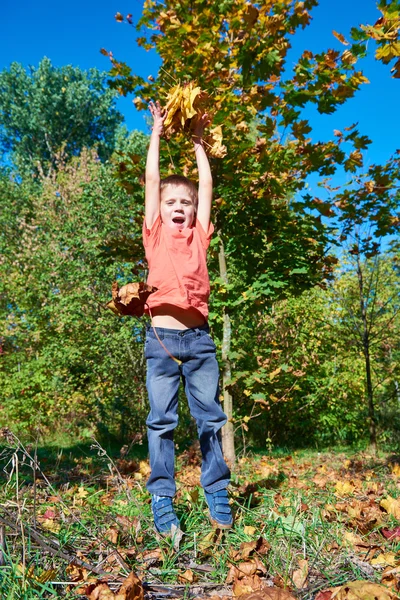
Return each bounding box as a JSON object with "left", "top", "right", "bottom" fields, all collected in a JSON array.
[{"left": 0, "top": 0, "right": 400, "bottom": 173}]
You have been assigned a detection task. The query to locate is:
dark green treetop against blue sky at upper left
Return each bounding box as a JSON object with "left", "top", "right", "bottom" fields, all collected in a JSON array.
[{"left": 0, "top": 58, "right": 123, "bottom": 173}]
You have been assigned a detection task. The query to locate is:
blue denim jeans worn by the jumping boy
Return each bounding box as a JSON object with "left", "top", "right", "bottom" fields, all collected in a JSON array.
[{"left": 145, "top": 325, "right": 230, "bottom": 496}]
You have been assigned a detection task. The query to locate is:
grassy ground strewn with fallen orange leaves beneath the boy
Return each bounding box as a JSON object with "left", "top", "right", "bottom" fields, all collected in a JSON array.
[{"left": 0, "top": 433, "right": 400, "bottom": 600}]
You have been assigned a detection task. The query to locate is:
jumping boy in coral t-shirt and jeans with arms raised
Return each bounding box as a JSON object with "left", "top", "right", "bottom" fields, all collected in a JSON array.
[{"left": 143, "top": 102, "right": 232, "bottom": 534}]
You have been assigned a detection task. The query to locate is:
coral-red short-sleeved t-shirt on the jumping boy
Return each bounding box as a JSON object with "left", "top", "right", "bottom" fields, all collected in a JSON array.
[{"left": 143, "top": 216, "right": 214, "bottom": 319}]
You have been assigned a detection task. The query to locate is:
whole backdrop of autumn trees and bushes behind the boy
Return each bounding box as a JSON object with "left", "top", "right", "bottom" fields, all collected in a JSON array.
[{"left": 0, "top": 0, "right": 400, "bottom": 461}]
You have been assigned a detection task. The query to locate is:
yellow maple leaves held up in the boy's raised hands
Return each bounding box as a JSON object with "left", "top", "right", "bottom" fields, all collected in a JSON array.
[{"left": 164, "top": 81, "right": 226, "bottom": 158}]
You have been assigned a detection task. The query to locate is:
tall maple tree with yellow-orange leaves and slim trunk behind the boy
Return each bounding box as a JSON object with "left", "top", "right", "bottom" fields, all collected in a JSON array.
[{"left": 102, "top": 0, "right": 395, "bottom": 462}]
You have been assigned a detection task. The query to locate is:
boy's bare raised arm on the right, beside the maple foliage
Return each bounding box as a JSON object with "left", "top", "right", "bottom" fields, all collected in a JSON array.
[{"left": 193, "top": 114, "right": 212, "bottom": 233}]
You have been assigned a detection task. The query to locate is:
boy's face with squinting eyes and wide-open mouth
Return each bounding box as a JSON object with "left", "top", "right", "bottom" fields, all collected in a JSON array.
[{"left": 160, "top": 185, "right": 196, "bottom": 229}]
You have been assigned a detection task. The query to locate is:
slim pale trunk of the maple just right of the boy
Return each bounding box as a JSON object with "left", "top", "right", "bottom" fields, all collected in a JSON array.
[{"left": 218, "top": 234, "right": 236, "bottom": 467}]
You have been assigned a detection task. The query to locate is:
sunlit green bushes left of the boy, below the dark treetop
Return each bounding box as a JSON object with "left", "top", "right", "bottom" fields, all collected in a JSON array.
[{"left": 0, "top": 141, "right": 148, "bottom": 437}]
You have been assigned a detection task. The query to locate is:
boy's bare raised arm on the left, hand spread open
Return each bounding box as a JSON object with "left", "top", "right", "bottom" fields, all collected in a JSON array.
[{"left": 145, "top": 101, "right": 167, "bottom": 229}]
